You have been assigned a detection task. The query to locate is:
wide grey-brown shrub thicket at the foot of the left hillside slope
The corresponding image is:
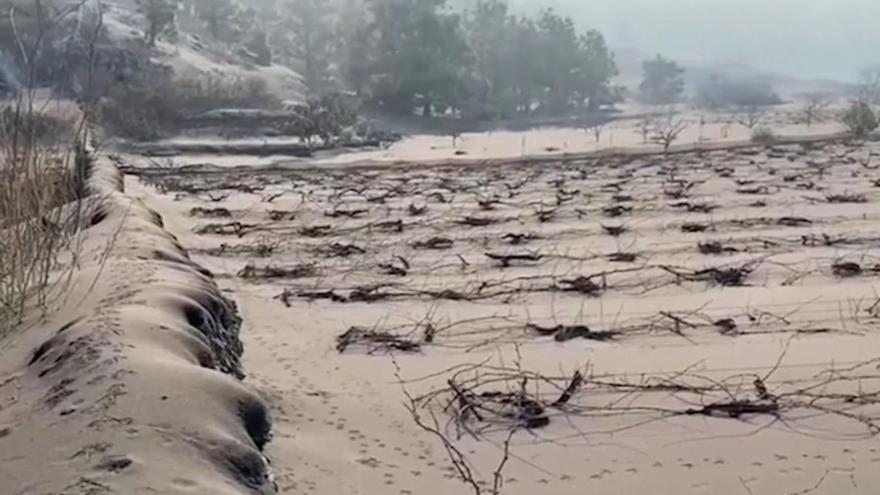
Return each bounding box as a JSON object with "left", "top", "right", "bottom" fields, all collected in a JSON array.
[{"left": 96, "top": 73, "right": 279, "bottom": 140}]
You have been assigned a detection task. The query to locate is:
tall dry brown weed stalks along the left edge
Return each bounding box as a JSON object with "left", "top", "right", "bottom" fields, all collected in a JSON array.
[{"left": 0, "top": 1, "right": 102, "bottom": 338}]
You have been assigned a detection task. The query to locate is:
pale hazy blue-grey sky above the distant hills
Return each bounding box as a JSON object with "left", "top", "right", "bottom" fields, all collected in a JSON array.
[{"left": 512, "top": 0, "right": 880, "bottom": 80}]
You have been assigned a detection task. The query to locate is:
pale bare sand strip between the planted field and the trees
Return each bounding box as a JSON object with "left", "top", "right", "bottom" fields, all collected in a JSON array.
[{"left": 117, "top": 107, "right": 844, "bottom": 172}]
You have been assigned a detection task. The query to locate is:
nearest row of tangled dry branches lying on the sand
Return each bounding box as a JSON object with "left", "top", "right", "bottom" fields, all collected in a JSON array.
[{"left": 414, "top": 340, "right": 880, "bottom": 438}]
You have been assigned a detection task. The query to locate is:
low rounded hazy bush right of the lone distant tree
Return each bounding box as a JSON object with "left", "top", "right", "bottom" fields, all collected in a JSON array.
[{"left": 694, "top": 74, "right": 782, "bottom": 109}]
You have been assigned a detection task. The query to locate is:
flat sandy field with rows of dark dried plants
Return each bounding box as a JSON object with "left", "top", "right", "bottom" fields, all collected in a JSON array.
[{"left": 128, "top": 135, "right": 880, "bottom": 495}]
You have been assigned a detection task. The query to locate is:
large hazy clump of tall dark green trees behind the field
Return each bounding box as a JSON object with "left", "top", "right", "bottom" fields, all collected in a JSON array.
[{"left": 273, "top": 0, "right": 619, "bottom": 119}]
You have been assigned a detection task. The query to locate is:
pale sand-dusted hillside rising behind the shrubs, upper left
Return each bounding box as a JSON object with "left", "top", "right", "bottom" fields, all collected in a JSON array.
[{"left": 0, "top": 0, "right": 306, "bottom": 101}]
